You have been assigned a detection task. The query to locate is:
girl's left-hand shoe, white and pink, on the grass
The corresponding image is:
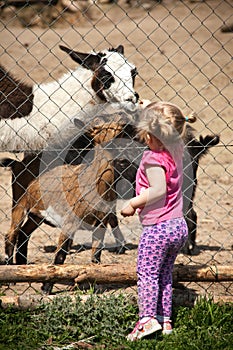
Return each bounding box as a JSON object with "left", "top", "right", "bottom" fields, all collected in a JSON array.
[{"left": 127, "top": 317, "right": 162, "bottom": 341}]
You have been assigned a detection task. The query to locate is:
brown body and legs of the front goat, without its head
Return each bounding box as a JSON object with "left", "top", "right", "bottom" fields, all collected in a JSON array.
[{"left": 5, "top": 146, "right": 123, "bottom": 293}]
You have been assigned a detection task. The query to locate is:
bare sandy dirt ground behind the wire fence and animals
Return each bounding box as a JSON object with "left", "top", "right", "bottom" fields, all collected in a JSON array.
[{"left": 0, "top": 0, "right": 233, "bottom": 296}]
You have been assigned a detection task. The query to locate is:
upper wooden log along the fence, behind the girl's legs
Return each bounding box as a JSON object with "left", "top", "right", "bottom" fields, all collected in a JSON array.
[{"left": 0, "top": 264, "right": 233, "bottom": 284}]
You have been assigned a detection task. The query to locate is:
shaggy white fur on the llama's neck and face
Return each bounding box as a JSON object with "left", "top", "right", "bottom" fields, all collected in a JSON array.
[{"left": 0, "top": 46, "right": 137, "bottom": 152}]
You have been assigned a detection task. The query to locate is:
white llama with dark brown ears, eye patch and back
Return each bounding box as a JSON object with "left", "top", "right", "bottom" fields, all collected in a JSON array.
[{"left": 0, "top": 45, "right": 138, "bottom": 152}]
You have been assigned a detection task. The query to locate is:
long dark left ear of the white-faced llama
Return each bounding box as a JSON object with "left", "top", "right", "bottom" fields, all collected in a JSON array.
[{"left": 59, "top": 45, "right": 101, "bottom": 71}]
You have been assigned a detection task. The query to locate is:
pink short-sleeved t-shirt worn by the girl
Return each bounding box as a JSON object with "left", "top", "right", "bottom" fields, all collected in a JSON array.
[{"left": 136, "top": 148, "right": 183, "bottom": 226}]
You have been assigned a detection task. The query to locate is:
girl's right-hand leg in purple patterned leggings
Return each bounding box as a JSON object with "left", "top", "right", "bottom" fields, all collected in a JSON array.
[{"left": 157, "top": 218, "right": 188, "bottom": 321}]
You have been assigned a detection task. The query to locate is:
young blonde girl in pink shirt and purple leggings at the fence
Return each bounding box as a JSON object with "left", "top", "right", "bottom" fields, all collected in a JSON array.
[{"left": 121, "top": 102, "right": 196, "bottom": 341}]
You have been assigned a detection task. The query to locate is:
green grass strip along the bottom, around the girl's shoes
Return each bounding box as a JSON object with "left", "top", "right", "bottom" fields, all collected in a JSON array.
[{"left": 0, "top": 295, "right": 233, "bottom": 350}]
